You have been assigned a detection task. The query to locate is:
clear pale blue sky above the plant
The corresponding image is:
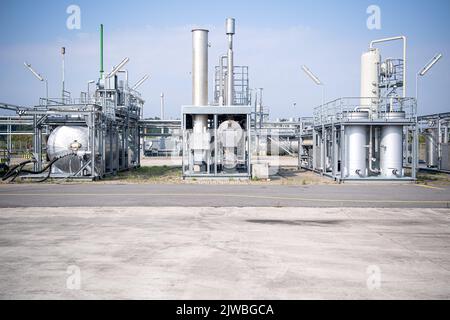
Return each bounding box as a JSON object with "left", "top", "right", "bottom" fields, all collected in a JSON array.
[{"left": 0, "top": 0, "right": 450, "bottom": 118}]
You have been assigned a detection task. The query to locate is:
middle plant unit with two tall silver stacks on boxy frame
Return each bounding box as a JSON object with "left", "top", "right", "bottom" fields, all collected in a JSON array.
[{"left": 181, "top": 18, "right": 251, "bottom": 179}]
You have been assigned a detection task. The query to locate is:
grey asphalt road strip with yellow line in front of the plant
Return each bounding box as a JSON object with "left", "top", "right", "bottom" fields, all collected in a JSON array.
[{"left": 0, "top": 183, "right": 450, "bottom": 208}]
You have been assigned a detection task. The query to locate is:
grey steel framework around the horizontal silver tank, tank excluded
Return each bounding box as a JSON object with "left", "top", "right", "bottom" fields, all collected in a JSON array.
[{"left": 0, "top": 76, "right": 144, "bottom": 180}]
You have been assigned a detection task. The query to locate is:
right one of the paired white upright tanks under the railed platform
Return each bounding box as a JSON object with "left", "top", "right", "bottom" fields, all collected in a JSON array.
[{"left": 380, "top": 112, "right": 405, "bottom": 178}]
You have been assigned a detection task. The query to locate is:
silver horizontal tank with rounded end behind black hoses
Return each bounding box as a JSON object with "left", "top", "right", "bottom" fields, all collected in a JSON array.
[{"left": 47, "top": 126, "right": 89, "bottom": 173}]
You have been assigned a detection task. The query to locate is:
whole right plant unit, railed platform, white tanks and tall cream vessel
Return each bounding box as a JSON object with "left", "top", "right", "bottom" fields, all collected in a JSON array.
[{"left": 298, "top": 36, "right": 418, "bottom": 181}]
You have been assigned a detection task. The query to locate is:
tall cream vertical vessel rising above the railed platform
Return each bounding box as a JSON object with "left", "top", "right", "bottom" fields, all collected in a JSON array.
[{"left": 361, "top": 48, "right": 381, "bottom": 112}]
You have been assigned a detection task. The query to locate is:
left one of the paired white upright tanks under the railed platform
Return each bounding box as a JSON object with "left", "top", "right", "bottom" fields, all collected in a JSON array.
[{"left": 344, "top": 111, "right": 369, "bottom": 177}]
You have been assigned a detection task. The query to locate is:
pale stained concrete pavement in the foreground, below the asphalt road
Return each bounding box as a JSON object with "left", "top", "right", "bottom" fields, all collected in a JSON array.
[{"left": 0, "top": 207, "right": 450, "bottom": 299}]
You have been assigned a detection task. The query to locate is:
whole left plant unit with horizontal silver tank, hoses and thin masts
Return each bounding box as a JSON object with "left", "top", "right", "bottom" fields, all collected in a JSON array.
[{"left": 0, "top": 25, "right": 148, "bottom": 181}]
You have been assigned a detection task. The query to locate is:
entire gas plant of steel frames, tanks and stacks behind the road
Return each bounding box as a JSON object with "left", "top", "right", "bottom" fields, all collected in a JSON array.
[{"left": 0, "top": 18, "right": 450, "bottom": 182}]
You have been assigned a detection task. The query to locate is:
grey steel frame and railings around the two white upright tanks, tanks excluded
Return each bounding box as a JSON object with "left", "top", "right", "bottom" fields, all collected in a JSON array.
[{"left": 306, "top": 97, "right": 418, "bottom": 181}]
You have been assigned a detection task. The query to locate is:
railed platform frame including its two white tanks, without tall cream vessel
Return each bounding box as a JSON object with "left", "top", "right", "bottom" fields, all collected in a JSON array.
[{"left": 302, "top": 97, "right": 418, "bottom": 181}]
